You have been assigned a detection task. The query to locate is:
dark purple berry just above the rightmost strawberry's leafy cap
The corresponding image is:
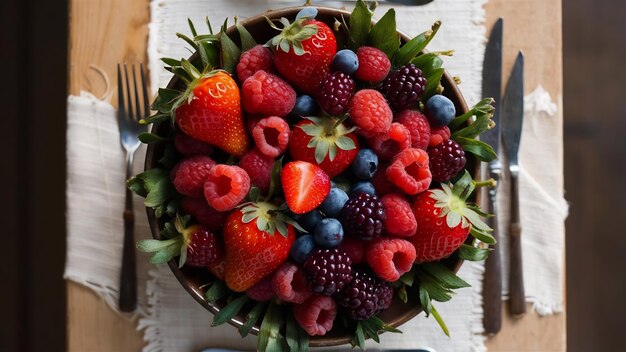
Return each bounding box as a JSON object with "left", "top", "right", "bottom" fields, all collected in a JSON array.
[{"left": 428, "top": 139, "right": 467, "bottom": 182}]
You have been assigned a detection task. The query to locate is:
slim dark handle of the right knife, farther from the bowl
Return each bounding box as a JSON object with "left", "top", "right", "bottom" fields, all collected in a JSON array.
[{"left": 509, "top": 168, "right": 526, "bottom": 317}]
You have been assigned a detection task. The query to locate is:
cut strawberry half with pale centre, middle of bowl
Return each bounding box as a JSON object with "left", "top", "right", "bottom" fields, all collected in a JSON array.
[{"left": 280, "top": 161, "right": 330, "bottom": 214}]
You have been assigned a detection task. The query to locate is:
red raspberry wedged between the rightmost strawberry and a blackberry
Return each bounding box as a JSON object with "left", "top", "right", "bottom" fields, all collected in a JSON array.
[{"left": 381, "top": 194, "right": 417, "bottom": 237}]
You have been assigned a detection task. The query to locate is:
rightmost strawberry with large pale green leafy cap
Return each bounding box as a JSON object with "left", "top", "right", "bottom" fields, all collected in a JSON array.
[{"left": 407, "top": 172, "right": 491, "bottom": 263}]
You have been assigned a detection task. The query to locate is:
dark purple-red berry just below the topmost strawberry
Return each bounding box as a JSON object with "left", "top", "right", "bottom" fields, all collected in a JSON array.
[{"left": 317, "top": 71, "right": 355, "bottom": 116}]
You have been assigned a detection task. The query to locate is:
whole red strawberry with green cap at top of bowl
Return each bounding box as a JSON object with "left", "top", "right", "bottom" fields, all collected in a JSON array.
[{"left": 266, "top": 18, "right": 337, "bottom": 95}]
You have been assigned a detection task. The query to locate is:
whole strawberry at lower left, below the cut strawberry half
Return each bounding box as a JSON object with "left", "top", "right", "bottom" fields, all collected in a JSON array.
[{"left": 223, "top": 202, "right": 296, "bottom": 292}]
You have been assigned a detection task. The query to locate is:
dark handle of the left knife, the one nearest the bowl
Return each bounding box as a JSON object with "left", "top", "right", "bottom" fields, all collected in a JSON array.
[{"left": 483, "top": 172, "right": 502, "bottom": 336}]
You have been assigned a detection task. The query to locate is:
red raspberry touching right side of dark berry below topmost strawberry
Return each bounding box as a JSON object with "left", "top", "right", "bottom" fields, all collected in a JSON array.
[{"left": 349, "top": 89, "right": 393, "bottom": 137}]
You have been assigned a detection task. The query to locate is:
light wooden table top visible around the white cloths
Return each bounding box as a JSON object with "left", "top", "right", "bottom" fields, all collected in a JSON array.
[{"left": 67, "top": 0, "right": 566, "bottom": 352}]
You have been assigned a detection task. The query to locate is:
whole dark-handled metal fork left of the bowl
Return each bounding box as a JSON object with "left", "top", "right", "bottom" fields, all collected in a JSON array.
[{"left": 117, "top": 64, "right": 150, "bottom": 312}]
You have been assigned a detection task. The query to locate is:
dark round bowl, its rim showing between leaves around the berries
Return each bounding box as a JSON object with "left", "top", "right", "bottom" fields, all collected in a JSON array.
[{"left": 145, "top": 7, "right": 474, "bottom": 347}]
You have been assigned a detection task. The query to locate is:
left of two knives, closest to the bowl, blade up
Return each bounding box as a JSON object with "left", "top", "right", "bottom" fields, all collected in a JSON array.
[{"left": 481, "top": 18, "right": 502, "bottom": 336}]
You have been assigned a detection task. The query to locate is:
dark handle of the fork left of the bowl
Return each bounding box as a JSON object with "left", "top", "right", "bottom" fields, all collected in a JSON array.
[{"left": 118, "top": 153, "right": 137, "bottom": 312}]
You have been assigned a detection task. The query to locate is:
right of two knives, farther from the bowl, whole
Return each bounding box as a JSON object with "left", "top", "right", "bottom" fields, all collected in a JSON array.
[{"left": 501, "top": 51, "right": 526, "bottom": 317}]
